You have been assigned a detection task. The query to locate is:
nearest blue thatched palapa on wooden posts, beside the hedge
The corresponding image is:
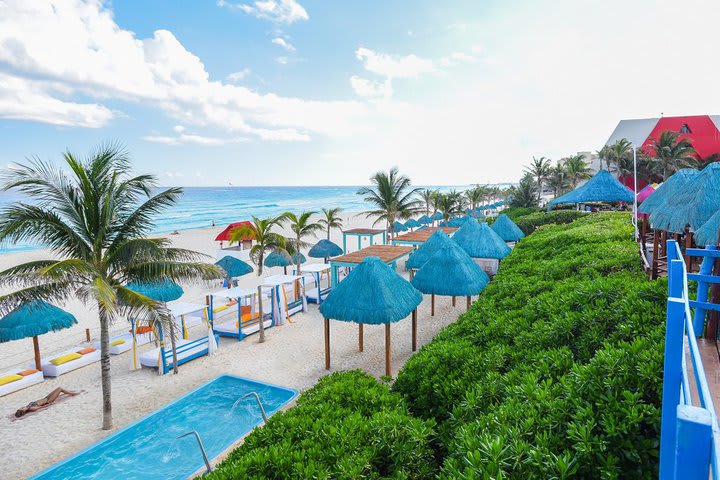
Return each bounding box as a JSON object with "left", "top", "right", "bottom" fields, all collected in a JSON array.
[{"left": 320, "top": 256, "right": 422, "bottom": 376}]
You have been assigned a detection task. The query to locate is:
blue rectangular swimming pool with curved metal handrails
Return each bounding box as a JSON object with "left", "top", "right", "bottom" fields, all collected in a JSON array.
[{"left": 33, "top": 375, "right": 297, "bottom": 480}]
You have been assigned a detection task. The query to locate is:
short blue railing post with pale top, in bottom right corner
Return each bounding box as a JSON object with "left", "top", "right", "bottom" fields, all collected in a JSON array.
[{"left": 674, "top": 405, "right": 712, "bottom": 480}]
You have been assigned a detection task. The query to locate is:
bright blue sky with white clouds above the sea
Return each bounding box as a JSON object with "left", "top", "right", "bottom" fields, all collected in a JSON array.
[{"left": 0, "top": 0, "right": 720, "bottom": 186}]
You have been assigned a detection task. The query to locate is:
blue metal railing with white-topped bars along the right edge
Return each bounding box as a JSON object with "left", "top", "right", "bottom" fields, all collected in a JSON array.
[{"left": 660, "top": 240, "right": 720, "bottom": 480}]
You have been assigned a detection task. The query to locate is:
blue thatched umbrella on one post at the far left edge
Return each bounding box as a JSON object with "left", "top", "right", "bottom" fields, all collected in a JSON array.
[{"left": 0, "top": 300, "right": 77, "bottom": 370}]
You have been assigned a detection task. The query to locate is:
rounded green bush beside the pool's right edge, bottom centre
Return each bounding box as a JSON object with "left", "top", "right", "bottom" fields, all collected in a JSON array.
[{"left": 203, "top": 370, "right": 437, "bottom": 479}]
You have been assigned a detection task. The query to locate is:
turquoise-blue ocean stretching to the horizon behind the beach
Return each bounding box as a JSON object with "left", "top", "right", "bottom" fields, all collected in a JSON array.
[{"left": 0, "top": 185, "right": 469, "bottom": 254}]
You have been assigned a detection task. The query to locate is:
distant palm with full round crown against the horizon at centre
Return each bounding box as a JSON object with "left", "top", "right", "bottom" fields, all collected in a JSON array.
[{"left": 357, "top": 167, "right": 427, "bottom": 238}]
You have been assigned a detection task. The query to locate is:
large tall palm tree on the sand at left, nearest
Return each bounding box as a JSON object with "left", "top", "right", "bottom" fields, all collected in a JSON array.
[{"left": 0, "top": 145, "right": 222, "bottom": 430}]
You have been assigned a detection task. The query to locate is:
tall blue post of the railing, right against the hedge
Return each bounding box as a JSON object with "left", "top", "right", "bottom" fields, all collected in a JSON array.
[{"left": 660, "top": 258, "right": 685, "bottom": 479}]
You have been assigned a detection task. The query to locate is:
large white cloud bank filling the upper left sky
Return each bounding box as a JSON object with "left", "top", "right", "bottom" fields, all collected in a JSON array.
[{"left": 0, "top": 0, "right": 366, "bottom": 141}]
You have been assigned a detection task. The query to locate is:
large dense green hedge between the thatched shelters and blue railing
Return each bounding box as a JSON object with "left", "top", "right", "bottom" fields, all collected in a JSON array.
[{"left": 393, "top": 213, "right": 665, "bottom": 478}]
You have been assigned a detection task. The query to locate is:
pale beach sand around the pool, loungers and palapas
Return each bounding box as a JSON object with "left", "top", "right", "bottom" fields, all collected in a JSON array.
[{"left": 0, "top": 214, "right": 465, "bottom": 479}]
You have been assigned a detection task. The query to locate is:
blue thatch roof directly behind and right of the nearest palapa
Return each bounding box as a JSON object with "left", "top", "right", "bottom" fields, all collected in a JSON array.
[{"left": 411, "top": 241, "right": 490, "bottom": 297}]
